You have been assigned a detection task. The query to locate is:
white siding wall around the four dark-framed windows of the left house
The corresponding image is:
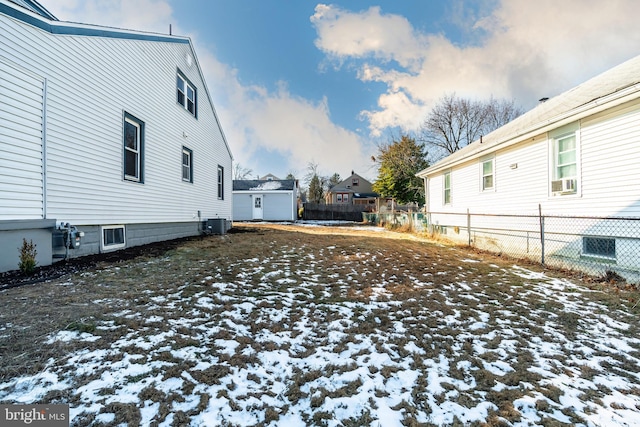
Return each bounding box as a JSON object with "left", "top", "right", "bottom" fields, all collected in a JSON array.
[{"left": 0, "top": 10, "right": 232, "bottom": 225}]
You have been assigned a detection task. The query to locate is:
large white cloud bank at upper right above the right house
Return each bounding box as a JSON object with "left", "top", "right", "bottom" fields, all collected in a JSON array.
[{"left": 311, "top": 0, "right": 640, "bottom": 135}]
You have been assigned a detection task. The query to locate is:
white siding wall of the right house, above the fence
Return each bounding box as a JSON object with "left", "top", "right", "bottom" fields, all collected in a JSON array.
[{"left": 428, "top": 101, "right": 640, "bottom": 216}]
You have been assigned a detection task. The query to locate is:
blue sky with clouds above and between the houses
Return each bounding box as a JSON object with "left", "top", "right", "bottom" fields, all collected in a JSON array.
[{"left": 41, "top": 0, "right": 640, "bottom": 180}]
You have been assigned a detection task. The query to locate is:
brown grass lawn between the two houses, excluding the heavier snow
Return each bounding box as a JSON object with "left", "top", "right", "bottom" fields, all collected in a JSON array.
[{"left": 0, "top": 224, "right": 639, "bottom": 425}]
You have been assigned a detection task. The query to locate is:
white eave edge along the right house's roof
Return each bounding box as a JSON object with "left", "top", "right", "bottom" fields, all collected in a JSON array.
[{"left": 416, "top": 83, "right": 640, "bottom": 178}]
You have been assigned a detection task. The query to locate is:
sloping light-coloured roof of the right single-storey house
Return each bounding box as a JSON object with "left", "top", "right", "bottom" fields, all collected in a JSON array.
[{"left": 417, "top": 56, "right": 640, "bottom": 177}]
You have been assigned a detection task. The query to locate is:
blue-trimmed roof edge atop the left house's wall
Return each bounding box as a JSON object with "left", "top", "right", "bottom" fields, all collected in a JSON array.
[{"left": 0, "top": 0, "right": 191, "bottom": 44}]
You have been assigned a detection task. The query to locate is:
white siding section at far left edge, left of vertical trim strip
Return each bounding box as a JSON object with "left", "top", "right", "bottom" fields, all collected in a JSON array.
[{"left": 0, "top": 59, "right": 44, "bottom": 220}]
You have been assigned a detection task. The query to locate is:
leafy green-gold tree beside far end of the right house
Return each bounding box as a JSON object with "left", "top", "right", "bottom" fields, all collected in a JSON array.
[{"left": 373, "top": 135, "right": 429, "bottom": 205}]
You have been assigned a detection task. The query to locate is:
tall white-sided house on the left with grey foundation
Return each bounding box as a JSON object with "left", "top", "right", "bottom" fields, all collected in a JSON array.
[{"left": 0, "top": 0, "right": 232, "bottom": 271}]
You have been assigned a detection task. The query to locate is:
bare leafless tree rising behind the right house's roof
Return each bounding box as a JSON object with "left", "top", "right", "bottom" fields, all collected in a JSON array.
[{"left": 418, "top": 94, "right": 522, "bottom": 162}]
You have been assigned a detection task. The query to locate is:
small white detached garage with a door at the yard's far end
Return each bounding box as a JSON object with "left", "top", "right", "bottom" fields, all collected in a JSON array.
[{"left": 233, "top": 179, "right": 298, "bottom": 221}]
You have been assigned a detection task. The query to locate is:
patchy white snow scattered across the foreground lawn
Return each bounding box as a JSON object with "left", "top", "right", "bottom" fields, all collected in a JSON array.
[{"left": 0, "top": 231, "right": 640, "bottom": 427}]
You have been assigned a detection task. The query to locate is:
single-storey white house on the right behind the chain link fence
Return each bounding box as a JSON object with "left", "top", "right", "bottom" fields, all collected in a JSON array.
[{"left": 417, "top": 52, "right": 640, "bottom": 280}]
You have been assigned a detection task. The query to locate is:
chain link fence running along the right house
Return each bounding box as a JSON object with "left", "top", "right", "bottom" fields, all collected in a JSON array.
[{"left": 365, "top": 212, "right": 640, "bottom": 284}]
